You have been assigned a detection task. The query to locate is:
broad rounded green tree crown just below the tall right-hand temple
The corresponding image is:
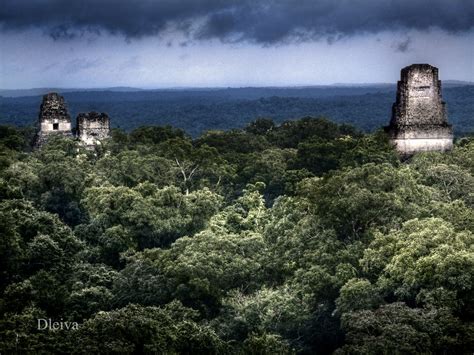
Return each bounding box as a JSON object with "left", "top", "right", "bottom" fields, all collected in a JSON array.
[{"left": 301, "top": 163, "right": 435, "bottom": 238}]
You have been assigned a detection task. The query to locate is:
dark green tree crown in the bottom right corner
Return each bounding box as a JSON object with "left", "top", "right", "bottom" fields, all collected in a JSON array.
[{"left": 337, "top": 302, "right": 474, "bottom": 354}]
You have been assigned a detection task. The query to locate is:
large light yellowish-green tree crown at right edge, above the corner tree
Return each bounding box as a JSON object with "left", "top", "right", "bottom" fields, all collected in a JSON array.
[{"left": 361, "top": 219, "right": 474, "bottom": 318}]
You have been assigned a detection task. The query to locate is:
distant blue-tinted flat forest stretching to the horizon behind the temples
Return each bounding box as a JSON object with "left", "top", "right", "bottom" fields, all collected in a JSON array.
[{"left": 0, "top": 85, "right": 474, "bottom": 136}]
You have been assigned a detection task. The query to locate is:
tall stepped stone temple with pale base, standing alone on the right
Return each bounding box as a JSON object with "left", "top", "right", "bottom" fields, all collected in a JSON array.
[{"left": 385, "top": 64, "right": 453, "bottom": 156}]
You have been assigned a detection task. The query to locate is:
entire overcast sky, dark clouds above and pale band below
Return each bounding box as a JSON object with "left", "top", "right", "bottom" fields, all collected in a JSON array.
[{"left": 0, "top": 0, "right": 474, "bottom": 89}]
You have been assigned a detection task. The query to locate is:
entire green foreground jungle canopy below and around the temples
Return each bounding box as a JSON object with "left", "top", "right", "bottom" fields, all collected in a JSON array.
[{"left": 0, "top": 119, "right": 474, "bottom": 354}]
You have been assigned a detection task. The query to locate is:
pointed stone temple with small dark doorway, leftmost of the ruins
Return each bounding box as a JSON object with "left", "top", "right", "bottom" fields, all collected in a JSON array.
[{"left": 36, "top": 92, "right": 72, "bottom": 146}]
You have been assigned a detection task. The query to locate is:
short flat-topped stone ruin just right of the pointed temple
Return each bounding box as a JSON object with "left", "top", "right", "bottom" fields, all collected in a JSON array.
[{"left": 76, "top": 112, "right": 110, "bottom": 147}]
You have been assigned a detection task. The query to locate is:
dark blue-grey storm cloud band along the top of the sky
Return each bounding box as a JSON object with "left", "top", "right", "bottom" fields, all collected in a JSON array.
[{"left": 0, "top": 0, "right": 474, "bottom": 44}]
